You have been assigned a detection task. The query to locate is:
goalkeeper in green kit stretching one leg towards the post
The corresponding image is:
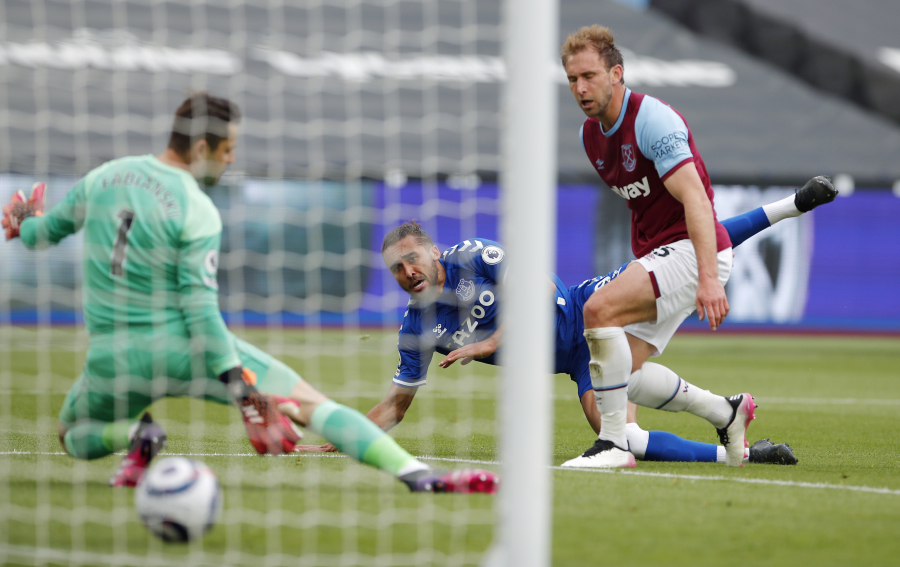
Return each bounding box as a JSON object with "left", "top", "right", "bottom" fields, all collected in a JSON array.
[{"left": 3, "top": 93, "right": 498, "bottom": 492}]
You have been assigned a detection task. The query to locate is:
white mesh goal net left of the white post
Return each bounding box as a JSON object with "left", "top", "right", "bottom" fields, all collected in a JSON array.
[{"left": 0, "top": 0, "right": 555, "bottom": 566}]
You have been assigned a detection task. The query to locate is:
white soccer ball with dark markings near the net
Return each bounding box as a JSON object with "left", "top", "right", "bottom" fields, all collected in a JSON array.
[{"left": 134, "top": 457, "right": 222, "bottom": 543}]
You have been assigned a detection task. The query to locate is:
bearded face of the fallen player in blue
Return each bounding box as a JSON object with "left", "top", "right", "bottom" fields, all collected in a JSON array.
[{"left": 383, "top": 236, "right": 444, "bottom": 303}]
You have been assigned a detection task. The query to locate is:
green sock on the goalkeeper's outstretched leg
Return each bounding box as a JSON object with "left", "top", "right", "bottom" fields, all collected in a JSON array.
[{"left": 309, "top": 400, "right": 429, "bottom": 476}]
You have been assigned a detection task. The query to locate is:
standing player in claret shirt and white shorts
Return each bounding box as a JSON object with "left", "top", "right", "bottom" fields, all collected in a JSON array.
[{"left": 561, "top": 25, "right": 833, "bottom": 467}]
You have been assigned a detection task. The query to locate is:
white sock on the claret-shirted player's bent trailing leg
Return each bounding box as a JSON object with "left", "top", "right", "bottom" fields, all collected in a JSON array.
[{"left": 628, "top": 362, "right": 734, "bottom": 429}]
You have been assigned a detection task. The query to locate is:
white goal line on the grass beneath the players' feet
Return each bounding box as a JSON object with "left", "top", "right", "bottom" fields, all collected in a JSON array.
[{"left": 0, "top": 451, "right": 900, "bottom": 496}]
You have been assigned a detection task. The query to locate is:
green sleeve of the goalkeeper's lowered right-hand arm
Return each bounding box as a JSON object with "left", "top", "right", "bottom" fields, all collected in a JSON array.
[{"left": 177, "top": 197, "right": 241, "bottom": 377}]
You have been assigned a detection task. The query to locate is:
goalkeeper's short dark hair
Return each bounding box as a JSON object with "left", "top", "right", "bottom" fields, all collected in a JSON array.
[{"left": 169, "top": 91, "right": 241, "bottom": 157}]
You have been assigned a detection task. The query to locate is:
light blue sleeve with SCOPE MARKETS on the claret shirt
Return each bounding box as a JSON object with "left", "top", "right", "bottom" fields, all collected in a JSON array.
[{"left": 634, "top": 96, "right": 694, "bottom": 178}]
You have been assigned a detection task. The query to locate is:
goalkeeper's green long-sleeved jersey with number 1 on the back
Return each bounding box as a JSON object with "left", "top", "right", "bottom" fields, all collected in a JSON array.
[{"left": 21, "top": 155, "right": 240, "bottom": 377}]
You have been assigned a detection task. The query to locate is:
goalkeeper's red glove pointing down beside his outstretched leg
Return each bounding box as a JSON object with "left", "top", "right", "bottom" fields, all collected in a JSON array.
[{"left": 219, "top": 366, "right": 301, "bottom": 455}]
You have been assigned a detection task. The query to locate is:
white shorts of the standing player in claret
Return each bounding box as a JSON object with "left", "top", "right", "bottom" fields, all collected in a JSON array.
[{"left": 625, "top": 240, "right": 734, "bottom": 356}]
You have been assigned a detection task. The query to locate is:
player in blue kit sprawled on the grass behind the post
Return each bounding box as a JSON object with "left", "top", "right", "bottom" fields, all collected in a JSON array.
[{"left": 301, "top": 186, "right": 827, "bottom": 464}]
